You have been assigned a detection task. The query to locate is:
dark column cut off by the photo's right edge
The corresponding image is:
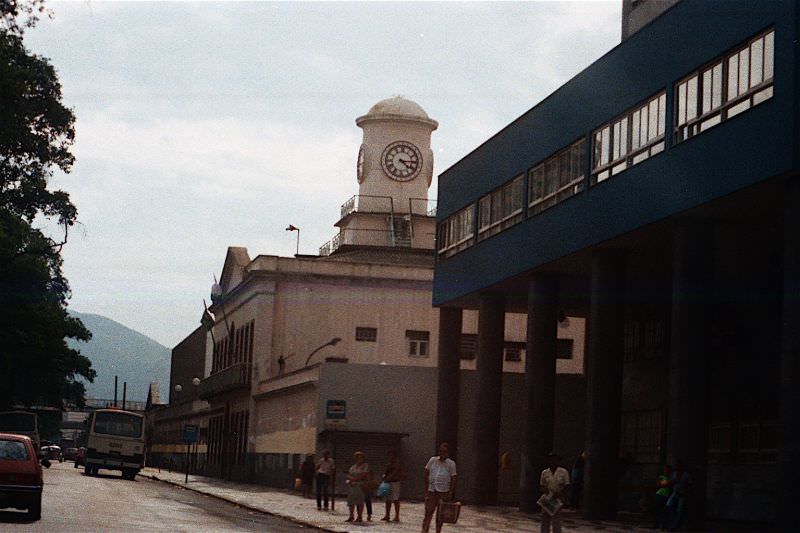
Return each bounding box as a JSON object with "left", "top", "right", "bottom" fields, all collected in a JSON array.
[{"left": 776, "top": 178, "right": 800, "bottom": 533}]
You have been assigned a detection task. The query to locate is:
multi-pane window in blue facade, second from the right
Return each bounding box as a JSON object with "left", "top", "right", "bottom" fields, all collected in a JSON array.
[{"left": 592, "top": 92, "right": 667, "bottom": 185}]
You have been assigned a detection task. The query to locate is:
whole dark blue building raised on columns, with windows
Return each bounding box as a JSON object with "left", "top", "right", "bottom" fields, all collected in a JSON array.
[{"left": 434, "top": 0, "right": 800, "bottom": 531}]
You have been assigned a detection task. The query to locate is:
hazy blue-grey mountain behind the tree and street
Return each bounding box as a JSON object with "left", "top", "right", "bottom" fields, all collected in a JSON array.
[{"left": 68, "top": 311, "right": 170, "bottom": 402}]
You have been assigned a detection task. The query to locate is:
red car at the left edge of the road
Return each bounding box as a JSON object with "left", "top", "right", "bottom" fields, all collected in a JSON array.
[{"left": 0, "top": 433, "right": 50, "bottom": 520}]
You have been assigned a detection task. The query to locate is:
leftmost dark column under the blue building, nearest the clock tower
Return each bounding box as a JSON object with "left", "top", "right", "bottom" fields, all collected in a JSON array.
[{"left": 438, "top": 307, "right": 463, "bottom": 460}]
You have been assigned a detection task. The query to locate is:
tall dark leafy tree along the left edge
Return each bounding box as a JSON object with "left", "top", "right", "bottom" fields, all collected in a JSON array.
[{"left": 0, "top": 0, "right": 95, "bottom": 409}]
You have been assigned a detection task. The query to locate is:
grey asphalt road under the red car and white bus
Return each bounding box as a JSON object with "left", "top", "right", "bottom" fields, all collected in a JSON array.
[{"left": 0, "top": 462, "right": 322, "bottom": 533}]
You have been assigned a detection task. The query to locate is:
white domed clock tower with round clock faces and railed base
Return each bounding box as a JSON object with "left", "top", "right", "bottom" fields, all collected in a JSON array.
[{"left": 320, "top": 96, "right": 439, "bottom": 255}]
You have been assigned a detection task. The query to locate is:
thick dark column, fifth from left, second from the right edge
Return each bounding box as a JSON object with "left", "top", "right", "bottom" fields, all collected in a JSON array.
[{"left": 667, "top": 220, "right": 714, "bottom": 525}]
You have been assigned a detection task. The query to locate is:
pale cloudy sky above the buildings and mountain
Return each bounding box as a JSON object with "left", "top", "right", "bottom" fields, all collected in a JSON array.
[{"left": 25, "top": 0, "right": 622, "bottom": 347}]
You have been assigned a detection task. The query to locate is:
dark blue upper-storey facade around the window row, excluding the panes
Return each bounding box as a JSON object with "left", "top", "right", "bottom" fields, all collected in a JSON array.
[{"left": 433, "top": 0, "right": 800, "bottom": 306}]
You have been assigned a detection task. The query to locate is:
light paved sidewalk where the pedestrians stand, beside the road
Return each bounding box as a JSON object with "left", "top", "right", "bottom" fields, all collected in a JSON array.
[{"left": 139, "top": 468, "right": 664, "bottom": 533}]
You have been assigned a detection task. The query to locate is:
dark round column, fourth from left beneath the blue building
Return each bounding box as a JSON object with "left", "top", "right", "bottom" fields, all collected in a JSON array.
[{"left": 583, "top": 250, "right": 625, "bottom": 519}]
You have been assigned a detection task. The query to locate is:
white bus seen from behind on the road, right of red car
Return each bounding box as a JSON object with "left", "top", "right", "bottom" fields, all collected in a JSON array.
[{"left": 85, "top": 409, "right": 144, "bottom": 479}]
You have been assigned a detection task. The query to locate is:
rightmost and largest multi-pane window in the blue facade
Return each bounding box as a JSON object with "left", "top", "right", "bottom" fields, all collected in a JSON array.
[{"left": 675, "top": 30, "right": 775, "bottom": 143}]
